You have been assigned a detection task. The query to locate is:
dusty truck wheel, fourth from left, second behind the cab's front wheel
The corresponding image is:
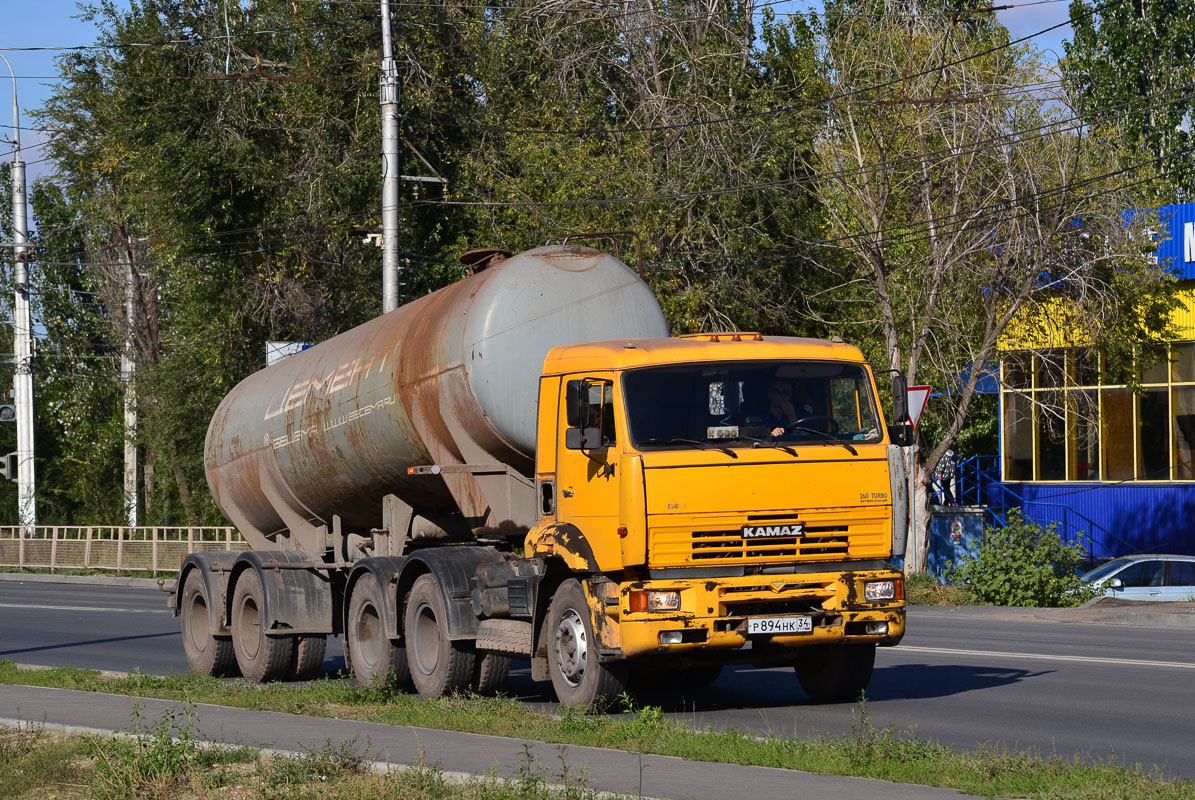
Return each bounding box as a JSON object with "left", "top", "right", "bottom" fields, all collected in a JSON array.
[{"left": 403, "top": 574, "right": 476, "bottom": 697}]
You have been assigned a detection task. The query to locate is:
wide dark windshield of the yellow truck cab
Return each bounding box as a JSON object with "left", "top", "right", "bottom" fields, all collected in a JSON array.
[{"left": 623, "top": 361, "right": 882, "bottom": 450}]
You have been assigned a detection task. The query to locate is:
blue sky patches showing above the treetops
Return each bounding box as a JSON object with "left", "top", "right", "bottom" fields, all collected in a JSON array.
[{"left": 0, "top": 0, "right": 1071, "bottom": 178}]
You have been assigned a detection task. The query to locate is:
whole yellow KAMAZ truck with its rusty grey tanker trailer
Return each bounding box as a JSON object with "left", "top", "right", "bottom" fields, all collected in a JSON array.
[{"left": 171, "top": 244, "right": 907, "bottom": 706}]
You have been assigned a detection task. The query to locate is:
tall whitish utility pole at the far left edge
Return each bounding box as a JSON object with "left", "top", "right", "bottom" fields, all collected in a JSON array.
[{"left": 0, "top": 55, "right": 37, "bottom": 525}]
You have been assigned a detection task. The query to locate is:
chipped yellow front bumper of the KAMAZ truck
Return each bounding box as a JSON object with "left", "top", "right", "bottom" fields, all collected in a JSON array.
[{"left": 602, "top": 569, "right": 905, "bottom": 661}]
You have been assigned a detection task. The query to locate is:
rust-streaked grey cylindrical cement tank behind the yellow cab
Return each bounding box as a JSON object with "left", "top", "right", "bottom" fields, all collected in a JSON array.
[{"left": 204, "top": 245, "right": 668, "bottom": 548}]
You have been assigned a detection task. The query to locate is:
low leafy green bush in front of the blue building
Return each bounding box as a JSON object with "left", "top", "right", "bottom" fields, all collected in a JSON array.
[{"left": 948, "top": 508, "right": 1096, "bottom": 606}]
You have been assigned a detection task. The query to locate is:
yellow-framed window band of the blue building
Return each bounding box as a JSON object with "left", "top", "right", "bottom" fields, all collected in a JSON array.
[{"left": 1000, "top": 342, "right": 1195, "bottom": 481}]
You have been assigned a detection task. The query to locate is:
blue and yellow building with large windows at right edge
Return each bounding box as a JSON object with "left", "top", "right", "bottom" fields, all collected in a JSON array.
[{"left": 994, "top": 203, "right": 1195, "bottom": 558}]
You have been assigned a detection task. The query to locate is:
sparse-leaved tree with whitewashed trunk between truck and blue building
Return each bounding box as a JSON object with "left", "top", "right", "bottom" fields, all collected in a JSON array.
[{"left": 811, "top": 1, "right": 1175, "bottom": 569}]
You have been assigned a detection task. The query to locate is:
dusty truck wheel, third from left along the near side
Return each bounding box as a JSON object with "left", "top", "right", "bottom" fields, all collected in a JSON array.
[{"left": 344, "top": 575, "right": 411, "bottom": 689}]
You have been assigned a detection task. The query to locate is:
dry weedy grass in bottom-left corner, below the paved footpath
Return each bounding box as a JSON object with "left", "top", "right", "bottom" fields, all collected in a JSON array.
[{"left": 0, "top": 710, "right": 620, "bottom": 800}]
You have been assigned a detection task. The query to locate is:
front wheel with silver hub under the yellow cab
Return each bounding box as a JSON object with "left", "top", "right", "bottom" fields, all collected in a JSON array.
[{"left": 546, "top": 579, "right": 626, "bottom": 706}]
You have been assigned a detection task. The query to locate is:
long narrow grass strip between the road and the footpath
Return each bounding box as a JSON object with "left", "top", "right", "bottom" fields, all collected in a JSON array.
[{"left": 0, "top": 660, "right": 1195, "bottom": 800}]
